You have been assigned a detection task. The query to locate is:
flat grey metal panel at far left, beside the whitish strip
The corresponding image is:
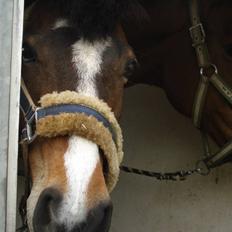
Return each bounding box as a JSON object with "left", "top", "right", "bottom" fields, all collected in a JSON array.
[{"left": 0, "top": 0, "right": 13, "bottom": 232}]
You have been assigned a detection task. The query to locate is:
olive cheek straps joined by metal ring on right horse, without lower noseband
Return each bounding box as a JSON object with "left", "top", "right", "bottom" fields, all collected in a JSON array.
[{"left": 190, "top": 0, "right": 232, "bottom": 128}]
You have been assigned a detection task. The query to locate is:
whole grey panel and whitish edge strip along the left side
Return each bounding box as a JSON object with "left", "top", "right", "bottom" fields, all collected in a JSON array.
[{"left": 0, "top": 0, "right": 23, "bottom": 232}]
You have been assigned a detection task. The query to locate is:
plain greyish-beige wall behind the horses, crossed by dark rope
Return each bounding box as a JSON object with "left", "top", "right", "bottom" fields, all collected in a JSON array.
[{"left": 16, "top": 86, "right": 232, "bottom": 232}]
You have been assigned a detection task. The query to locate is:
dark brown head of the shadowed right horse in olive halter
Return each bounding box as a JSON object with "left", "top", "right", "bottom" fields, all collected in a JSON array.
[{"left": 125, "top": 0, "right": 232, "bottom": 145}]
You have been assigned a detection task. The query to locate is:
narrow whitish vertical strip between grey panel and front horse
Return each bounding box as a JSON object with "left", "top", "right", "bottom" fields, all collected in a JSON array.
[{"left": 6, "top": 0, "right": 24, "bottom": 232}]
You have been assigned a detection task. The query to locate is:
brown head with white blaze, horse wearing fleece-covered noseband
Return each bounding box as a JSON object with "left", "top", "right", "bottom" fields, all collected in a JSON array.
[{"left": 22, "top": 0, "right": 136, "bottom": 232}]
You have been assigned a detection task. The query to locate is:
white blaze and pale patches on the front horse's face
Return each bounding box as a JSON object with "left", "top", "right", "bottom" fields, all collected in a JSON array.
[{"left": 28, "top": 38, "right": 111, "bottom": 231}]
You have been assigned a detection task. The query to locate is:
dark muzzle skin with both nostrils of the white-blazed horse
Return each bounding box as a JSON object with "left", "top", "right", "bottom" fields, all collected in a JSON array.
[{"left": 33, "top": 188, "right": 113, "bottom": 232}]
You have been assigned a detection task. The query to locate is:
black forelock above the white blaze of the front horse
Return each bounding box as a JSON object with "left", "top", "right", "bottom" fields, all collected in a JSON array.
[{"left": 66, "top": 0, "right": 141, "bottom": 40}]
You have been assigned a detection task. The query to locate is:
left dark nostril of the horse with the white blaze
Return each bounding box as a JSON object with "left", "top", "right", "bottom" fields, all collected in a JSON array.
[{"left": 33, "top": 188, "right": 62, "bottom": 232}]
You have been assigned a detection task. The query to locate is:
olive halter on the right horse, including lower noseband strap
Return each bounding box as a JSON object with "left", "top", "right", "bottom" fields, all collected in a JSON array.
[{"left": 189, "top": 0, "right": 232, "bottom": 168}]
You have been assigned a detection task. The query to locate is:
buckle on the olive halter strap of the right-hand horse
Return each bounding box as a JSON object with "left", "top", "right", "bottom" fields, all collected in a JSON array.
[{"left": 189, "top": 23, "right": 206, "bottom": 47}]
